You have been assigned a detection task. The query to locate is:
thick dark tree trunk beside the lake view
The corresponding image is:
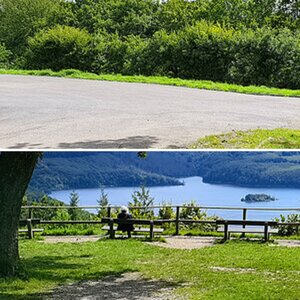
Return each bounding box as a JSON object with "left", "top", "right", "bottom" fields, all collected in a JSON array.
[{"left": 0, "top": 152, "right": 41, "bottom": 276}]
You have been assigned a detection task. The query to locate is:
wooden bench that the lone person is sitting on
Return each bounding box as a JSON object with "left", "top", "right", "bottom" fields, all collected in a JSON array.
[{"left": 102, "top": 218, "right": 164, "bottom": 240}]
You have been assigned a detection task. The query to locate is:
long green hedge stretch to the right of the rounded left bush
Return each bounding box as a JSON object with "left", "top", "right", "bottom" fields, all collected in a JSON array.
[{"left": 90, "top": 21, "right": 300, "bottom": 89}]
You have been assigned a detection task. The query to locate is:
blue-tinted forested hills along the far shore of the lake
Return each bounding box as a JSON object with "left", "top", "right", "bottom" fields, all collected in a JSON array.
[{"left": 30, "top": 152, "right": 300, "bottom": 192}]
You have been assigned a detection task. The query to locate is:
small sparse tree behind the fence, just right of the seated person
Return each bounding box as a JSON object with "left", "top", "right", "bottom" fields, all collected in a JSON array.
[{"left": 128, "top": 186, "right": 154, "bottom": 218}]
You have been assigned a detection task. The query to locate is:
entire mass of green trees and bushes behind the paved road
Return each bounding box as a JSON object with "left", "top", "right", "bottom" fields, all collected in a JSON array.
[{"left": 0, "top": 0, "right": 300, "bottom": 89}]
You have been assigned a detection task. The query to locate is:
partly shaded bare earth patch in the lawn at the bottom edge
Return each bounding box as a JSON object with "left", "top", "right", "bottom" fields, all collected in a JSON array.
[{"left": 43, "top": 272, "right": 185, "bottom": 300}]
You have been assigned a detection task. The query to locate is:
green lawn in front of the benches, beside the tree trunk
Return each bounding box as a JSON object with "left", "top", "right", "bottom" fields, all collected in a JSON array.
[{"left": 0, "top": 240, "right": 300, "bottom": 300}]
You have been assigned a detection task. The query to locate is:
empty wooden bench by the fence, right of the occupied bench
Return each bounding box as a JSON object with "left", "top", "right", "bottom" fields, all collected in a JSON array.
[{"left": 216, "top": 220, "right": 278, "bottom": 242}]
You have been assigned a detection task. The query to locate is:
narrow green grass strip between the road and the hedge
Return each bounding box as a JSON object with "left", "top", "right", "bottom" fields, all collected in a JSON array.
[{"left": 0, "top": 69, "right": 300, "bottom": 97}]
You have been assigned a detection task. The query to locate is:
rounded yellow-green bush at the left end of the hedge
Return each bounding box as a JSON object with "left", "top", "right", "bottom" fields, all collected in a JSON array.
[{"left": 26, "top": 25, "right": 93, "bottom": 71}]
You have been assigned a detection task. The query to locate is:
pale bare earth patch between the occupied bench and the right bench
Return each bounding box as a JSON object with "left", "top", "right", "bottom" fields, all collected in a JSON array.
[{"left": 149, "top": 236, "right": 216, "bottom": 250}]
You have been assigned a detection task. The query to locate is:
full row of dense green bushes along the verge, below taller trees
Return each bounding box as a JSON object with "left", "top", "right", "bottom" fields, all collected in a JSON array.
[{"left": 27, "top": 21, "right": 300, "bottom": 89}]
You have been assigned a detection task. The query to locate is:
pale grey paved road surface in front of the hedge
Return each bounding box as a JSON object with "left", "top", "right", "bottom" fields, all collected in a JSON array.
[{"left": 0, "top": 75, "right": 300, "bottom": 149}]
